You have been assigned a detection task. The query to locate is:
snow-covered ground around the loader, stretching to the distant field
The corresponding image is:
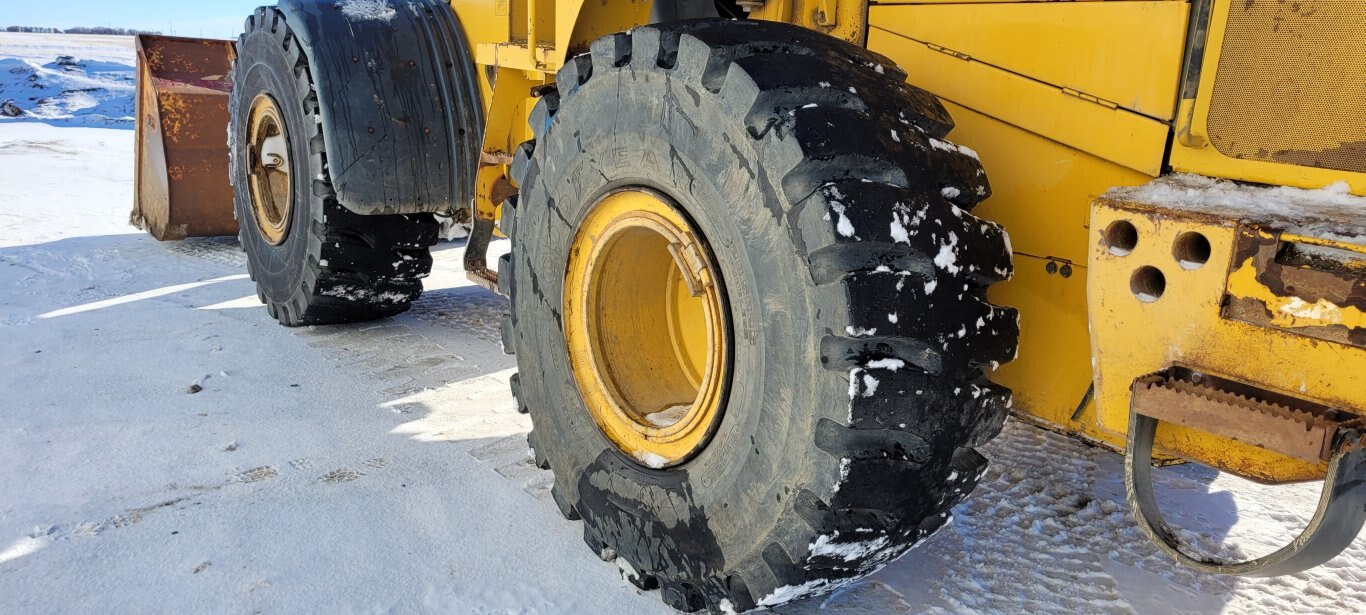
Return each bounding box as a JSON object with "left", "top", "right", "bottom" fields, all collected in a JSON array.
[{"left": 0, "top": 34, "right": 1366, "bottom": 615}]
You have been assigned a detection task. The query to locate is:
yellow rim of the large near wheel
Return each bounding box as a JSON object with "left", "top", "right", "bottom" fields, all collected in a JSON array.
[{"left": 564, "top": 187, "right": 731, "bottom": 467}]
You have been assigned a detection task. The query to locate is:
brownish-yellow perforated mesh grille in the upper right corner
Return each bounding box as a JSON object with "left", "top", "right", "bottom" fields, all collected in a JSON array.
[{"left": 1209, "top": 0, "right": 1366, "bottom": 172}]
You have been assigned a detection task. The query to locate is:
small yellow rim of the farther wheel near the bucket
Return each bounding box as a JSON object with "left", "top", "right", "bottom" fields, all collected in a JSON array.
[{"left": 247, "top": 94, "right": 294, "bottom": 246}]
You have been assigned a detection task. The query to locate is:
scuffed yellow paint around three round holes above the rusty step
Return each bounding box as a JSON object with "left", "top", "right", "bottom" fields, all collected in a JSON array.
[{"left": 1086, "top": 197, "right": 1366, "bottom": 482}]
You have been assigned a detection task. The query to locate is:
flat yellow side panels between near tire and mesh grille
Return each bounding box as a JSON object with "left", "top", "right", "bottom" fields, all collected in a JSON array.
[{"left": 869, "top": 3, "right": 1184, "bottom": 448}]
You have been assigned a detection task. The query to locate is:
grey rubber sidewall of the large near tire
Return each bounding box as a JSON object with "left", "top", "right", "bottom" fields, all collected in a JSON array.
[{"left": 514, "top": 62, "right": 848, "bottom": 590}]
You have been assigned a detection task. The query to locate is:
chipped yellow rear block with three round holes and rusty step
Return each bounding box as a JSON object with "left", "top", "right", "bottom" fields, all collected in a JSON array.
[{"left": 1087, "top": 190, "right": 1366, "bottom": 482}]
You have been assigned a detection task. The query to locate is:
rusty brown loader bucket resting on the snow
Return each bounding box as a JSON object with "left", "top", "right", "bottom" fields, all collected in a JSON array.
[{"left": 130, "top": 34, "right": 238, "bottom": 241}]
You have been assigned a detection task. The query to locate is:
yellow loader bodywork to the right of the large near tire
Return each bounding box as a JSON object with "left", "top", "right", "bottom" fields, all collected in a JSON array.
[{"left": 867, "top": 0, "right": 1366, "bottom": 482}]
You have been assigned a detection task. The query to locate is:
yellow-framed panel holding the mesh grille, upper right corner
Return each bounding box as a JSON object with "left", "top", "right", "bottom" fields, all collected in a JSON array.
[{"left": 1169, "top": 0, "right": 1366, "bottom": 195}]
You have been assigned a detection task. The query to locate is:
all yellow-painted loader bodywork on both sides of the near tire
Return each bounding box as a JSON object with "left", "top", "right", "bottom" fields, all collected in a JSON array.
[{"left": 452, "top": 0, "right": 1366, "bottom": 482}]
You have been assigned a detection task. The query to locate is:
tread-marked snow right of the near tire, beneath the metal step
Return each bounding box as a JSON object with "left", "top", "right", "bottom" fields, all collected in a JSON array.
[{"left": 779, "top": 420, "right": 1366, "bottom": 615}]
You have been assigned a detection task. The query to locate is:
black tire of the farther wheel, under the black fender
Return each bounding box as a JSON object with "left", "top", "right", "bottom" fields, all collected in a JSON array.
[{"left": 228, "top": 7, "right": 438, "bottom": 327}]
